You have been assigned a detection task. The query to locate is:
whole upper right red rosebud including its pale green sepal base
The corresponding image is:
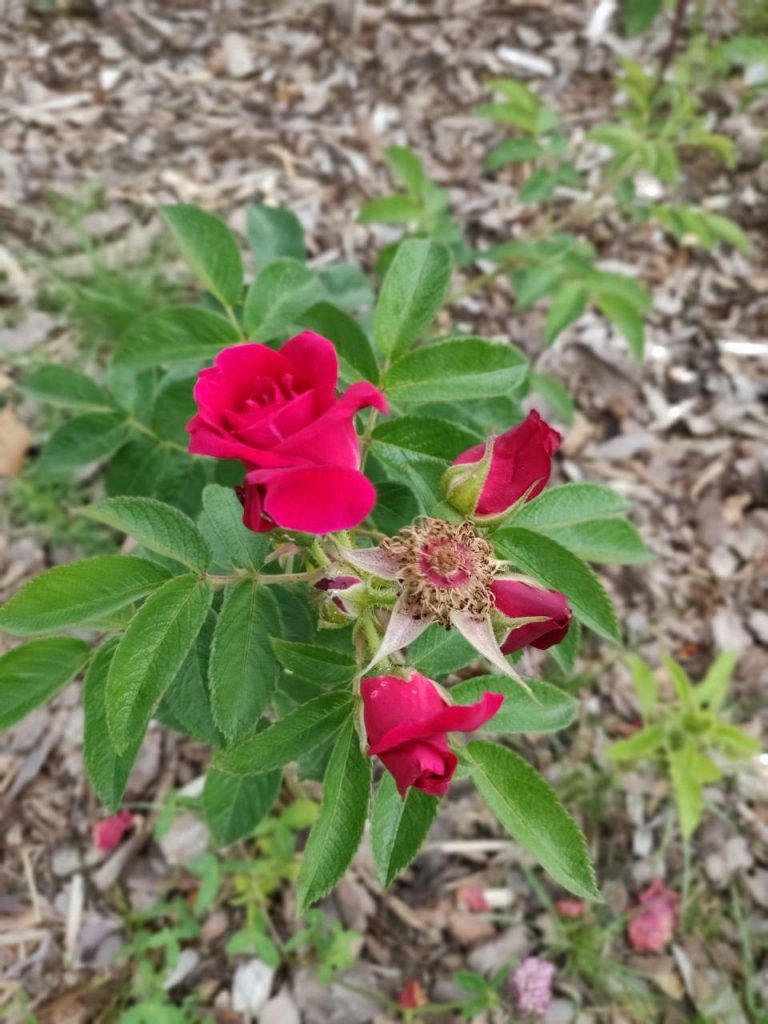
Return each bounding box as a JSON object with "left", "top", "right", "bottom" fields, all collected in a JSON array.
[{"left": 442, "top": 411, "right": 560, "bottom": 519}]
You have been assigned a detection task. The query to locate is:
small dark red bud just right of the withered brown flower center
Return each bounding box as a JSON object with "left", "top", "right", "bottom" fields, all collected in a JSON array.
[{"left": 490, "top": 580, "right": 571, "bottom": 654}]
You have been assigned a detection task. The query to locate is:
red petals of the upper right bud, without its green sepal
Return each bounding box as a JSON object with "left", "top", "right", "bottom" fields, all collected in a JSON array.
[{"left": 454, "top": 411, "right": 560, "bottom": 516}]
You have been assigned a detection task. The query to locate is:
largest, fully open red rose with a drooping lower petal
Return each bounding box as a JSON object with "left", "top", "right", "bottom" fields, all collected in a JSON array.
[{"left": 186, "top": 331, "right": 387, "bottom": 534}]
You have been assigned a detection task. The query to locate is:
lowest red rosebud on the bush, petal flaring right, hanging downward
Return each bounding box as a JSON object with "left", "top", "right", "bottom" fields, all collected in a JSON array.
[{"left": 360, "top": 672, "right": 504, "bottom": 799}]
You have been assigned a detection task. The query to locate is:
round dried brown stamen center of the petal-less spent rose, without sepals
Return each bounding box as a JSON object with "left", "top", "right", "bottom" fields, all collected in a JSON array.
[{"left": 382, "top": 518, "right": 495, "bottom": 628}]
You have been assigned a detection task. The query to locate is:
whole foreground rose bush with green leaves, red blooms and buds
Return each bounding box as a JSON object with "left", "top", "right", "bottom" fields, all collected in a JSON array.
[{"left": 0, "top": 206, "right": 647, "bottom": 912}]
